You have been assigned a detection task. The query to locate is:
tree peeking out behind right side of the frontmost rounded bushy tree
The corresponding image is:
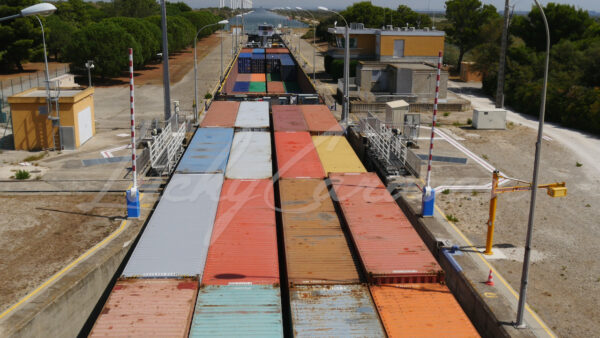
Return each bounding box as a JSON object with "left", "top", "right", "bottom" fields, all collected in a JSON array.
[{"left": 102, "top": 17, "right": 161, "bottom": 66}]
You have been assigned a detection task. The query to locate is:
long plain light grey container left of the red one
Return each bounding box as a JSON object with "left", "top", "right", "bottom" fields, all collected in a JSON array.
[{"left": 123, "top": 173, "right": 223, "bottom": 278}]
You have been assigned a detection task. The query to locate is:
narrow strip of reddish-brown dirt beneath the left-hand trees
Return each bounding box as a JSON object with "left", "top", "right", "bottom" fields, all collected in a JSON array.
[{"left": 97, "top": 33, "right": 224, "bottom": 87}]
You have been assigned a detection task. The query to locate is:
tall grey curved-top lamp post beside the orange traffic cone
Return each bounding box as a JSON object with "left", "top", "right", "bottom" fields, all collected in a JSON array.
[{"left": 516, "top": 0, "right": 550, "bottom": 328}]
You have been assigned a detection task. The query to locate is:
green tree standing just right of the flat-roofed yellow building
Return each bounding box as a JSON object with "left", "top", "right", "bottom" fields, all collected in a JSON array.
[{"left": 446, "top": 0, "right": 499, "bottom": 69}]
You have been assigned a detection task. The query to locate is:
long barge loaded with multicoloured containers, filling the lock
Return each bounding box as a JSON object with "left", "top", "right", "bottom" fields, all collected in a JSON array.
[{"left": 89, "top": 27, "right": 479, "bottom": 337}]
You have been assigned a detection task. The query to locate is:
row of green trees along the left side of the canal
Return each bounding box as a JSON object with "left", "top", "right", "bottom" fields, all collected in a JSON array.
[{"left": 0, "top": 0, "right": 221, "bottom": 78}]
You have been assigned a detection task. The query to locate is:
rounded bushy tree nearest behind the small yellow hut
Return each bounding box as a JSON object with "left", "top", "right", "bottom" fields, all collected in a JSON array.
[{"left": 65, "top": 22, "right": 142, "bottom": 78}]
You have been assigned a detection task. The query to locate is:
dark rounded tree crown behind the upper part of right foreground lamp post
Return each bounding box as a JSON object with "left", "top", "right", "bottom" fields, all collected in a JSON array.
[{"left": 511, "top": 3, "right": 594, "bottom": 51}]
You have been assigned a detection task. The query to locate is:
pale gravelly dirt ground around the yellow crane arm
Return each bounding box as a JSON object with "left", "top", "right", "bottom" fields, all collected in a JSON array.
[{"left": 434, "top": 123, "right": 600, "bottom": 337}]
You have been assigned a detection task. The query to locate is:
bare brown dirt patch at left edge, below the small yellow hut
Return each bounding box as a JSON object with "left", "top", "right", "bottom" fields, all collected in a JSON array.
[{"left": 0, "top": 194, "right": 126, "bottom": 312}]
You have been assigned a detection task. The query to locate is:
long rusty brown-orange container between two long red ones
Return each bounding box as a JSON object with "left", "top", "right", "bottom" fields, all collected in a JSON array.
[{"left": 279, "top": 179, "right": 360, "bottom": 285}]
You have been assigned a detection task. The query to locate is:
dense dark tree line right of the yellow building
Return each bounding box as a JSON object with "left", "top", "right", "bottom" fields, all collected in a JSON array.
[{"left": 446, "top": 0, "right": 600, "bottom": 133}]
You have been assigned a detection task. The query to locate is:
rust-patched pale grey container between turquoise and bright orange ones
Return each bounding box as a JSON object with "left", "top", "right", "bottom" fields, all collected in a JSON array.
[{"left": 290, "top": 285, "right": 385, "bottom": 338}]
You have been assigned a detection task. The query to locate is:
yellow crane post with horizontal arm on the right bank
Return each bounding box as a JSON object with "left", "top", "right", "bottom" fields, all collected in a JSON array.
[{"left": 483, "top": 170, "right": 567, "bottom": 255}]
